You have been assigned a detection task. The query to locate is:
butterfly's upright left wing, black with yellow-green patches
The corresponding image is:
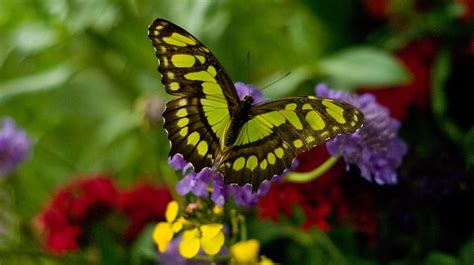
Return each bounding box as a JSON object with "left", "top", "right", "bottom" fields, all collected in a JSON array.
[{"left": 148, "top": 19, "right": 239, "bottom": 171}]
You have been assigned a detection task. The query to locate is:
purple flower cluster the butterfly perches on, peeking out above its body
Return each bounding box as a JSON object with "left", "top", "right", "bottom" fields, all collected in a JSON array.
[{"left": 168, "top": 83, "right": 270, "bottom": 207}]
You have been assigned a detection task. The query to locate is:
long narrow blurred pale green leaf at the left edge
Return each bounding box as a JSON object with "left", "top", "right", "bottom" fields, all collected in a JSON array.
[{"left": 0, "top": 64, "right": 74, "bottom": 103}]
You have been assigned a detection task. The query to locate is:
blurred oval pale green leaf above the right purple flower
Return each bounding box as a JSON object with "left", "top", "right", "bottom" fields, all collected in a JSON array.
[{"left": 318, "top": 46, "right": 410, "bottom": 89}]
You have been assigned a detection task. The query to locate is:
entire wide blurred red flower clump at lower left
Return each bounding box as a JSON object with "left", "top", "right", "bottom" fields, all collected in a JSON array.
[{"left": 35, "top": 175, "right": 172, "bottom": 255}]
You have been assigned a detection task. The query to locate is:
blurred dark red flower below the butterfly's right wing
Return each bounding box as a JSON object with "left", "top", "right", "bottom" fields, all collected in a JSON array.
[{"left": 257, "top": 146, "right": 379, "bottom": 239}]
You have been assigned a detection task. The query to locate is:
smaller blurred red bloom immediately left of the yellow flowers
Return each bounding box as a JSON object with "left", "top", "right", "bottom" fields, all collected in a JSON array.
[{"left": 119, "top": 183, "right": 172, "bottom": 242}]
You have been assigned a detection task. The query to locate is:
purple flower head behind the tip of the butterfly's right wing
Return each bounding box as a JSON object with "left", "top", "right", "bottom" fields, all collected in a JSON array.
[{"left": 316, "top": 84, "right": 407, "bottom": 184}]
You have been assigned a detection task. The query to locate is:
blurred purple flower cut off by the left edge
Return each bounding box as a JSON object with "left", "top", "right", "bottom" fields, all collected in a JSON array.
[{"left": 0, "top": 118, "right": 31, "bottom": 176}]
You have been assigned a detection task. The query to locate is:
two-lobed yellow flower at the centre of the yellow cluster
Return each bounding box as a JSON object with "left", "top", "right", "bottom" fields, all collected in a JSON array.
[{"left": 179, "top": 224, "right": 225, "bottom": 259}]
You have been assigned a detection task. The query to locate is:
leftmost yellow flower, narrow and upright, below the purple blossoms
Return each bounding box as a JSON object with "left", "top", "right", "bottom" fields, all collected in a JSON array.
[{"left": 153, "top": 201, "right": 183, "bottom": 253}]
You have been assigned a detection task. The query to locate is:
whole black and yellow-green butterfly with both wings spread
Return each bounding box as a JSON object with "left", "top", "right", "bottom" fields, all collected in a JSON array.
[{"left": 148, "top": 18, "right": 364, "bottom": 191}]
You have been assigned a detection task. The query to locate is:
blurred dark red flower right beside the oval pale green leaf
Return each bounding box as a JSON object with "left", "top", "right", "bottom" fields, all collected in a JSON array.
[{"left": 361, "top": 40, "right": 437, "bottom": 120}]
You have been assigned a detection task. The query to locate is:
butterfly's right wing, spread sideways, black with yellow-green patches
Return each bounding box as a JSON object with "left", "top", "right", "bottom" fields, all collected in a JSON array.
[{"left": 218, "top": 97, "right": 364, "bottom": 190}]
